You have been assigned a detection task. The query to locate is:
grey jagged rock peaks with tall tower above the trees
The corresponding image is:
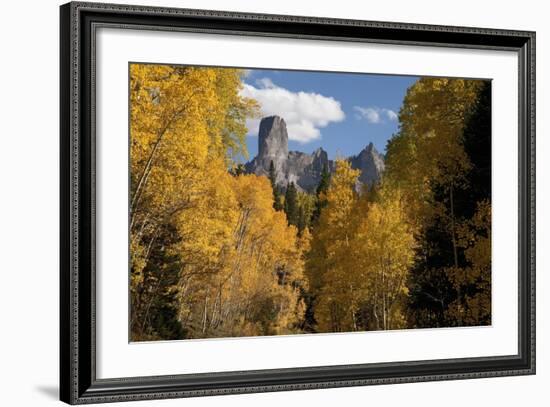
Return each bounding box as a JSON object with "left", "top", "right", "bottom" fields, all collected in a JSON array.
[{"left": 245, "top": 116, "right": 384, "bottom": 192}]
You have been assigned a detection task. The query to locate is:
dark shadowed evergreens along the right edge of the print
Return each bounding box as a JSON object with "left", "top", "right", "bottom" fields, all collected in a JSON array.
[{"left": 409, "top": 83, "right": 491, "bottom": 327}]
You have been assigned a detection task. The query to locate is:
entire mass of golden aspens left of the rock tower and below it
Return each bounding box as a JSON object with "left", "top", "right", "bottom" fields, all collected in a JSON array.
[{"left": 130, "top": 65, "right": 303, "bottom": 340}]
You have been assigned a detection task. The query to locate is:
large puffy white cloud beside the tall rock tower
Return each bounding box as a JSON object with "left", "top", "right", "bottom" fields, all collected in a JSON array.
[{"left": 241, "top": 78, "right": 346, "bottom": 143}]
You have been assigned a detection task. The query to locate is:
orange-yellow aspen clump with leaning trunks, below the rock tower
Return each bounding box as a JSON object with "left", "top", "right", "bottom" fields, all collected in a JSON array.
[{"left": 181, "top": 175, "right": 303, "bottom": 337}]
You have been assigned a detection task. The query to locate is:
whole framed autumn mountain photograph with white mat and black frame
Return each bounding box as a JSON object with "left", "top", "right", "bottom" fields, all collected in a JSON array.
[{"left": 60, "top": 2, "right": 535, "bottom": 404}]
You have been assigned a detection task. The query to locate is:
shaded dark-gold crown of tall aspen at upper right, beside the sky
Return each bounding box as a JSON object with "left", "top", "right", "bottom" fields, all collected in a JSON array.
[{"left": 385, "top": 78, "right": 483, "bottom": 230}]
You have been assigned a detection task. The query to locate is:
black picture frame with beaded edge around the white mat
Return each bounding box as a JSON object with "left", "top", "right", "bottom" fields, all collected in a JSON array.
[{"left": 60, "top": 2, "right": 535, "bottom": 404}]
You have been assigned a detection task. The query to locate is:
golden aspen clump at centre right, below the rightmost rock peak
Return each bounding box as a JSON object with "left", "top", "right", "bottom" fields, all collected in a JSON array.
[{"left": 306, "top": 161, "right": 415, "bottom": 332}]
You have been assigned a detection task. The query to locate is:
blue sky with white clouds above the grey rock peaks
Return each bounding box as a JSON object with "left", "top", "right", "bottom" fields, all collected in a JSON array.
[{"left": 243, "top": 69, "right": 418, "bottom": 159}]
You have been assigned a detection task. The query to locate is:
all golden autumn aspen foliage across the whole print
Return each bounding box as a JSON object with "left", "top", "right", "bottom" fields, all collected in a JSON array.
[{"left": 130, "top": 64, "right": 496, "bottom": 340}]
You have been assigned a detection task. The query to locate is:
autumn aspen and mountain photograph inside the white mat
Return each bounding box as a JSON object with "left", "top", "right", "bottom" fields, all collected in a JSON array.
[{"left": 130, "top": 62, "right": 492, "bottom": 342}]
